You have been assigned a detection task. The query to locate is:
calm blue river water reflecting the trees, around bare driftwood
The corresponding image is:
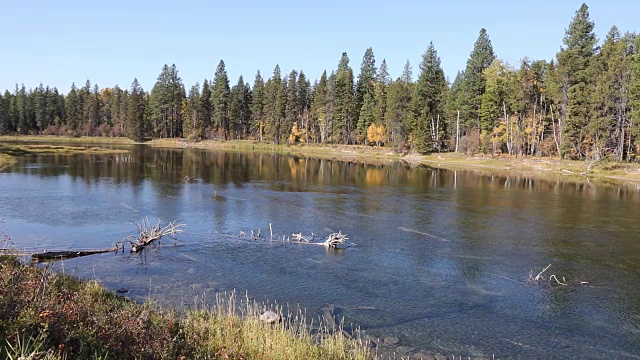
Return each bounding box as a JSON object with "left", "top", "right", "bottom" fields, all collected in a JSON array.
[{"left": 0, "top": 146, "right": 640, "bottom": 359}]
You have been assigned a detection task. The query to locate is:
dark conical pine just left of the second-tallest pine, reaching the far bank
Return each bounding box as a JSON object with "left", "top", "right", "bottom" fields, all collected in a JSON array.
[{"left": 411, "top": 42, "right": 447, "bottom": 153}]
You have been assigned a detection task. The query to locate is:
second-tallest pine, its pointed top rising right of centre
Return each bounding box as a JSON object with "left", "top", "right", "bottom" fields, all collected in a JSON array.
[{"left": 460, "top": 28, "right": 496, "bottom": 147}]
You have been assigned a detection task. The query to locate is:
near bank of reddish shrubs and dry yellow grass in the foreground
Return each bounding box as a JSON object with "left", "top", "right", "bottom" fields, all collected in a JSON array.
[{"left": 0, "top": 256, "right": 371, "bottom": 360}]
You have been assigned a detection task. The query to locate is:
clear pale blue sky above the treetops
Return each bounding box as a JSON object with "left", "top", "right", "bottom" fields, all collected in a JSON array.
[{"left": 0, "top": 0, "right": 640, "bottom": 93}]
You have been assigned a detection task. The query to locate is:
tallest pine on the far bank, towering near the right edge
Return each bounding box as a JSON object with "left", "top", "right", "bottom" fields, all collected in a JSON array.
[{"left": 557, "top": 4, "right": 597, "bottom": 158}]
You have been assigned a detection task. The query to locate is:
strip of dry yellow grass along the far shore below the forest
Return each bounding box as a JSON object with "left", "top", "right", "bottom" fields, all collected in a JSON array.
[{"left": 0, "top": 135, "right": 640, "bottom": 183}]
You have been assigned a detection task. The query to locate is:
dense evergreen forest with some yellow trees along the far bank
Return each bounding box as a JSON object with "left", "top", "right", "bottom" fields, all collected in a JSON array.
[{"left": 0, "top": 4, "right": 640, "bottom": 160}]
